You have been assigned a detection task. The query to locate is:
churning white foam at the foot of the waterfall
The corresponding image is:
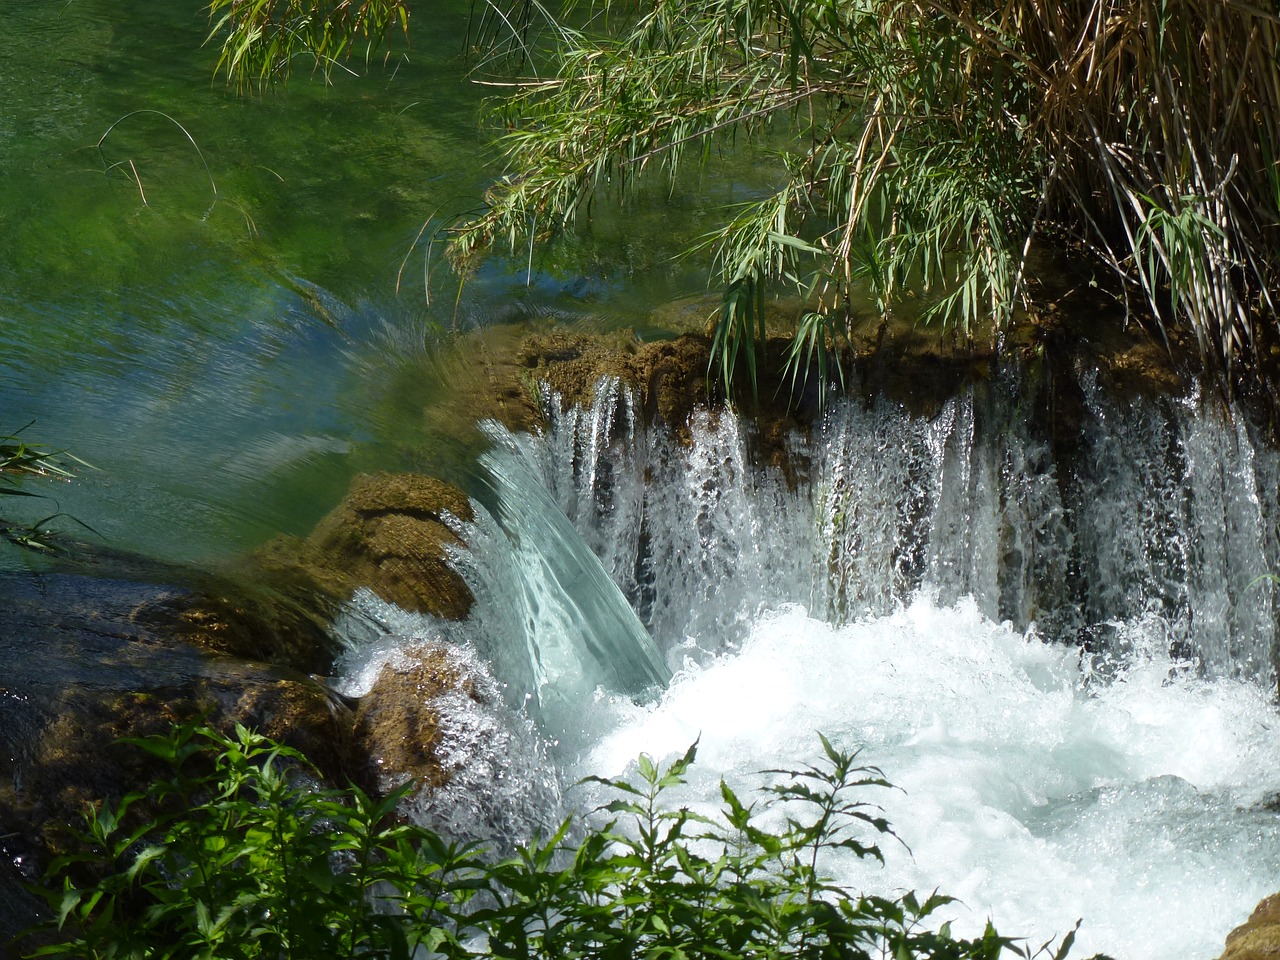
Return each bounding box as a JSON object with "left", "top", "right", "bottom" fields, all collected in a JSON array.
[{"left": 575, "top": 599, "right": 1280, "bottom": 960}]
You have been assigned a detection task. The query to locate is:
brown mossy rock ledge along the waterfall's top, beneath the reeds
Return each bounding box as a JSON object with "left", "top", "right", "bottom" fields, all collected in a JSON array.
[{"left": 409, "top": 281, "right": 1193, "bottom": 463}]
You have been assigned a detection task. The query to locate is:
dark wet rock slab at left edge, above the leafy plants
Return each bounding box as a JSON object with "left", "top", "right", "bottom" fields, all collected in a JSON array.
[{"left": 0, "top": 564, "right": 360, "bottom": 931}]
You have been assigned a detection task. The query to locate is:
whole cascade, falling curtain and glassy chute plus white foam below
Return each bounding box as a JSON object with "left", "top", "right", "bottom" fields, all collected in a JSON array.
[{"left": 335, "top": 366, "right": 1280, "bottom": 960}]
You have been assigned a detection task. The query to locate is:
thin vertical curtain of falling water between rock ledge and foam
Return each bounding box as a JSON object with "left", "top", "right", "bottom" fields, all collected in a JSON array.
[{"left": 522, "top": 363, "right": 1280, "bottom": 689}]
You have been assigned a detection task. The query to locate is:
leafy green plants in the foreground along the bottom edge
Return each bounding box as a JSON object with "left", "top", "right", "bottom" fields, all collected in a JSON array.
[{"left": 22, "top": 727, "right": 1100, "bottom": 960}]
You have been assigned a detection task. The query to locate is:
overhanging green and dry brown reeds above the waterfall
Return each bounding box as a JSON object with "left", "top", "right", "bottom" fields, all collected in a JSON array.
[{"left": 214, "top": 0, "right": 1280, "bottom": 399}]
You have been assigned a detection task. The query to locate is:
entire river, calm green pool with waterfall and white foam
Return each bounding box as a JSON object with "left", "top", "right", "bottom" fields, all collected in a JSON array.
[{"left": 0, "top": 0, "right": 1280, "bottom": 960}]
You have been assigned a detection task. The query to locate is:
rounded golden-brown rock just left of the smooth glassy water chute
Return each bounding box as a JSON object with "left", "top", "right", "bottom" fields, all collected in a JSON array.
[{"left": 253, "top": 474, "right": 472, "bottom": 620}]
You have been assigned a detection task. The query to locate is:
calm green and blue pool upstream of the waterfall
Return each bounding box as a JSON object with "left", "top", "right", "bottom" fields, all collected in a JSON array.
[{"left": 0, "top": 0, "right": 732, "bottom": 563}]
